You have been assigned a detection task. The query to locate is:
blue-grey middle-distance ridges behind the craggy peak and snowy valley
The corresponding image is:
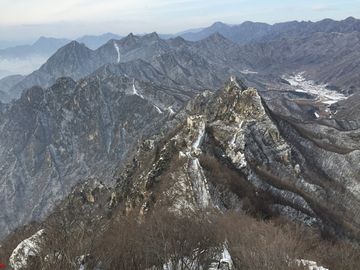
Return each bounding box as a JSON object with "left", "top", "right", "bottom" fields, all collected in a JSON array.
[{"left": 0, "top": 31, "right": 359, "bottom": 102}]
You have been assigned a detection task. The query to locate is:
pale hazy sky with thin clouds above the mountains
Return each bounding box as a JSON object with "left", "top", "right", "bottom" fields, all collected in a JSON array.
[{"left": 0, "top": 0, "right": 360, "bottom": 40}]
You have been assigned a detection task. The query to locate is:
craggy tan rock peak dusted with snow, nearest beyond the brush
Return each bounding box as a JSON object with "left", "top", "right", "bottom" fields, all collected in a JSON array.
[{"left": 112, "top": 76, "right": 295, "bottom": 216}]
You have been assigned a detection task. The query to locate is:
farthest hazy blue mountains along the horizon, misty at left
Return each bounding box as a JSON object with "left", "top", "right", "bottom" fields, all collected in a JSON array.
[{"left": 0, "top": 17, "right": 359, "bottom": 78}]
